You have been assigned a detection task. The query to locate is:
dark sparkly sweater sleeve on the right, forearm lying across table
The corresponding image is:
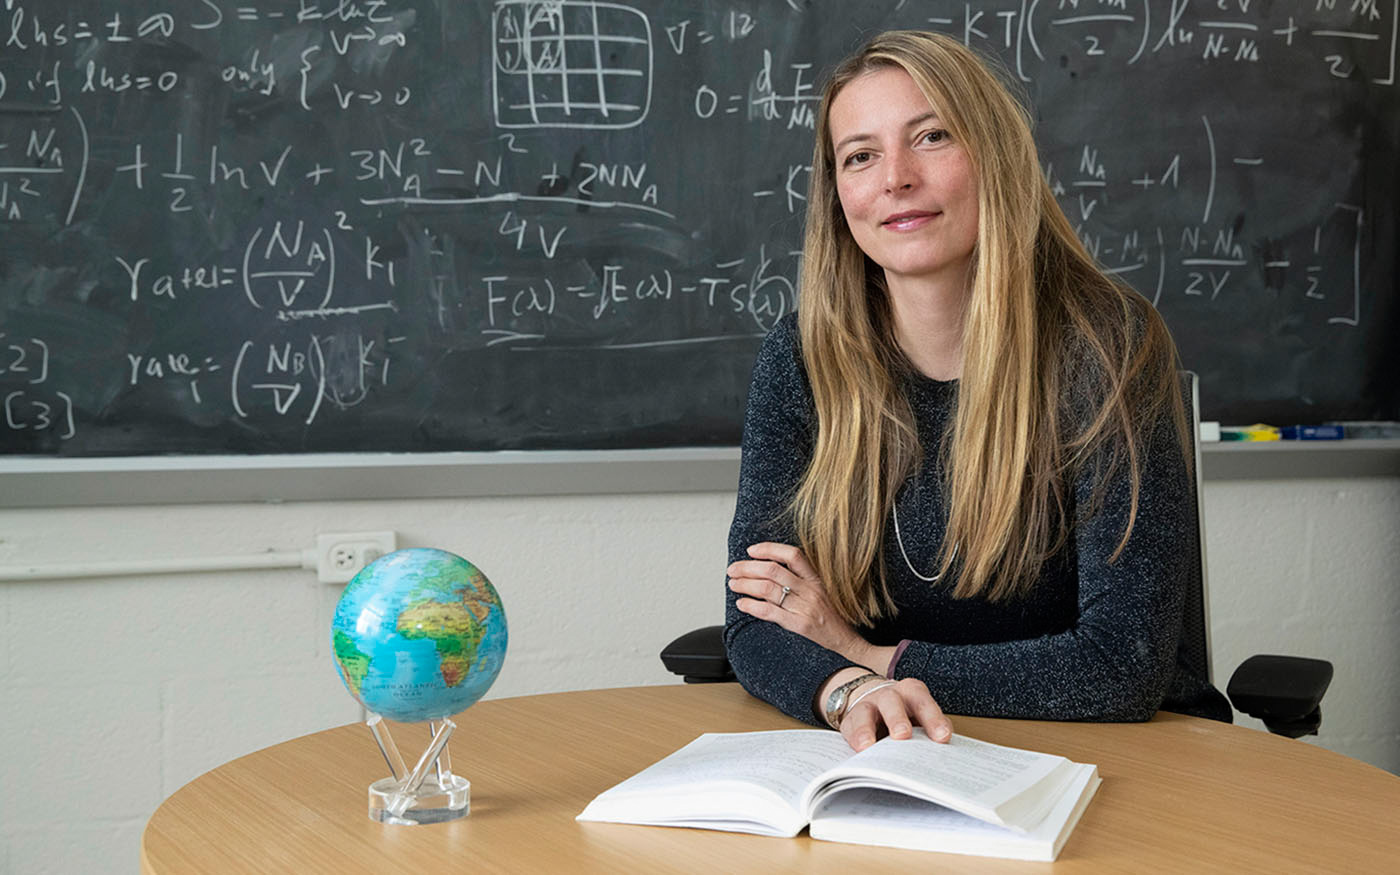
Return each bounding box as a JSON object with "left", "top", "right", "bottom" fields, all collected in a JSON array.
[{"left": 895, "top": 411, "right": 1191, "bottom": 721}]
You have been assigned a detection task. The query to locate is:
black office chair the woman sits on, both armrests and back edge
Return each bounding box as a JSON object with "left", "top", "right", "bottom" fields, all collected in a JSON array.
[{"left": 661, "top": 371, "right": 1333, "bottom": 738}]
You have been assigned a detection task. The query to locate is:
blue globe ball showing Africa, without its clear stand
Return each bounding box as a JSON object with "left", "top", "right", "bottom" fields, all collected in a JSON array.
[{"left": 330, "top": 547, "right": 508, "bottom": 722}]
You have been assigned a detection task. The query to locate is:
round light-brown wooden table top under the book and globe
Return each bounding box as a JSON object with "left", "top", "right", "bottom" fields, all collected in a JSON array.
[{"left": 141, "top": 683, "right": 1400, "bottom": 875}]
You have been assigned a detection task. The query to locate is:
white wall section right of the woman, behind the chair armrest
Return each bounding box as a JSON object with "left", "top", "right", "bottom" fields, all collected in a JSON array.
[{"left": 1205, "top": 477, "right": 1400, "bottom": 774}]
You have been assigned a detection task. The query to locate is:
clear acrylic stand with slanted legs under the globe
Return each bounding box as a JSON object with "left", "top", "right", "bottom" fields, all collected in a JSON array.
[{"left": 365, "top": 714, "right": 472, "bottom": 826}]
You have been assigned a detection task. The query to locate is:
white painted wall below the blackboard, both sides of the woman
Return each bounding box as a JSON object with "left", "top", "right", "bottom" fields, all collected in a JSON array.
[{"left": 0, "top": 479, "right": 1400, "bottom": 875}]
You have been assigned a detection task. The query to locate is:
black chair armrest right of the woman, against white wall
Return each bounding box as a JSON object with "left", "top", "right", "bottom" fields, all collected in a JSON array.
[{"left": 1225, "top": 655, "right": 1331, "bottom": 738}]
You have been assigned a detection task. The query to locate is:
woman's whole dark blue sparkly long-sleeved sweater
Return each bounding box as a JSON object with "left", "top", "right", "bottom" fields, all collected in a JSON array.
[{"left": 724, "top": 316, "right": 1231, "bottom": 725}]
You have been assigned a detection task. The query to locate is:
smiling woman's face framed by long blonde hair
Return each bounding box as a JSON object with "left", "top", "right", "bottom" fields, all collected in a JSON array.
[{"left": 830, "top": 67, "right": 977, "bottom": 296}]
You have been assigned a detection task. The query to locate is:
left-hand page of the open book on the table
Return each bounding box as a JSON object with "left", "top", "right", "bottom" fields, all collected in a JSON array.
[{"left": 578, "top": 729, "right": 851, "bottom": 834}]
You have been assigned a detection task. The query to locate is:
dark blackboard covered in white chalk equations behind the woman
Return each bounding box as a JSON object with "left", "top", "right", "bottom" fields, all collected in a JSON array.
[{"left": 0, "top": 0, "right": 1400, "bottom": 455}]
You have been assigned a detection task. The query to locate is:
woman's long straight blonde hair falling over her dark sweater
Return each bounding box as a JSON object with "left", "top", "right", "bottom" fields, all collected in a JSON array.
[{"left": 791, "top": 31, "right": 1187, "bottom": 624}]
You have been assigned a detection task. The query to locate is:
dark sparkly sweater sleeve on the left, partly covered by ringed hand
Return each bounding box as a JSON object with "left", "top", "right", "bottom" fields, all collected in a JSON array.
[{"left": 724, "top": 316, "right": 851, "bottom": 725}]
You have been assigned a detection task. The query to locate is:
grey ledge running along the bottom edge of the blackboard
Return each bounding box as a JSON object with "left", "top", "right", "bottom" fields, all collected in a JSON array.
[{"left": 0, "top": 440, "right": 1400, "bottom": 508}]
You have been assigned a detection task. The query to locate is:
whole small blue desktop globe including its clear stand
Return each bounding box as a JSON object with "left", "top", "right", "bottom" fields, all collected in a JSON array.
[{"left": 330, "top": 547, "right": 507, "bottom": 825}]
